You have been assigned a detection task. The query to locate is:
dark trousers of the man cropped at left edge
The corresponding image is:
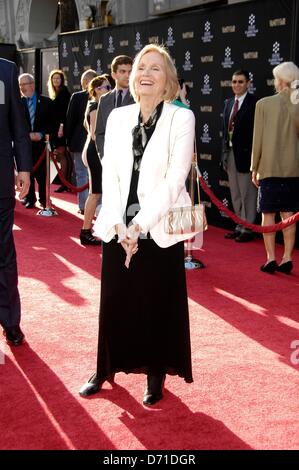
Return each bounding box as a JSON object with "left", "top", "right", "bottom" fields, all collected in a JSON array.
[{"left": 0, "top": 198, "right": 21, "bottom": 327}]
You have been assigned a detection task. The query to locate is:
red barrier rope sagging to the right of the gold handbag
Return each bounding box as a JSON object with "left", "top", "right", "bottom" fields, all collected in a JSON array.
[{"left": 196, "top": 166, "right": 299, "bottom": 233}]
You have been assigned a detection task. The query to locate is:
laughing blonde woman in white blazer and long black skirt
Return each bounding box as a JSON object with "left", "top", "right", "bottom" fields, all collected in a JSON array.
[{"left": 80, "top": 45, "right": 195, "bottom": 405}]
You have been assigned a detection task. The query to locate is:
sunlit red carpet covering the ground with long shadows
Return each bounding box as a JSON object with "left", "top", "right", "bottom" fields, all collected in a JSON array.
[{"left": 0, "top": 188, "right": 299, "bottom": 450}]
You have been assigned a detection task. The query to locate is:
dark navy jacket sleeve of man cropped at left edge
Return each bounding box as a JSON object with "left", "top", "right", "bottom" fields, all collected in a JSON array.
[{"left": 10, "top": 64, "right": 32, "bottom": 171}]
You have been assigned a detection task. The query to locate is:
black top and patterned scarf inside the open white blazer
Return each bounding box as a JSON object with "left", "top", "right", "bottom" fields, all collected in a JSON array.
[{"left": 125, "top": 101, "right": 163, "bottom": 226}]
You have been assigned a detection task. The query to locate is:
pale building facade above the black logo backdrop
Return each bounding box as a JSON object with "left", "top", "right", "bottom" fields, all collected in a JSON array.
[{"left": 0, "top": 0, "right": 248, "bottom": 49}]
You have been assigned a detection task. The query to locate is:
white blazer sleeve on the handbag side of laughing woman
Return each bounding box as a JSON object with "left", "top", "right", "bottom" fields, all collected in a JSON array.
[{"left": 133, "top": 108, "right": 195, "bottom": 233}]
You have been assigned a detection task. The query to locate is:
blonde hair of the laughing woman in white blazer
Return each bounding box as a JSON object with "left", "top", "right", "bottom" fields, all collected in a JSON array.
[{"left": 129, "top": 44, "right": 178, "bottom": 103}]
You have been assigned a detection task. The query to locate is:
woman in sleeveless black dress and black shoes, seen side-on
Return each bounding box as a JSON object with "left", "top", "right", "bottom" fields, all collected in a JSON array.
[{"left": 80, "top": 74, "right": 111, "bottom": 245}]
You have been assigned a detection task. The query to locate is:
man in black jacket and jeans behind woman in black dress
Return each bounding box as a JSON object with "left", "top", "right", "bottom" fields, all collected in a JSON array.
[{"left": 65, "top": 69, "right": 97, "bottom": 214}]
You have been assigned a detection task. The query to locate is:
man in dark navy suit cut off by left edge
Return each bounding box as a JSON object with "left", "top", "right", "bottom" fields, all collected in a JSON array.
[{"left": 0, "top": 59, "right": 32, "bottom": 346}]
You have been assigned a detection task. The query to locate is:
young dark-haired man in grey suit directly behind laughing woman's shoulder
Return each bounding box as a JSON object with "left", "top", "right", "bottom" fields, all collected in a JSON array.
[{"left": 95, "top": 55, "right": 134, "bottom": 158}]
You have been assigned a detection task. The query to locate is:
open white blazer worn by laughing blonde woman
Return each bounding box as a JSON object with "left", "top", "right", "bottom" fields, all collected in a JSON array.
[{"left": 94, "top": 103, "right": 195, "bottom": 248}]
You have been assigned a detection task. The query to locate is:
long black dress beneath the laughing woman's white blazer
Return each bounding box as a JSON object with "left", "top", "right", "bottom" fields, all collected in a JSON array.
[{"left": 97, "top": 102, "right": 193, "bottom": 383}]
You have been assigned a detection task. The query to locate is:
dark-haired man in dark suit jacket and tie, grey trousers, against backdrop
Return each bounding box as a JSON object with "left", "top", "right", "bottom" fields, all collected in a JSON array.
[{"left": 222, "top": 70, "right": 257, "bottom": 242}]
